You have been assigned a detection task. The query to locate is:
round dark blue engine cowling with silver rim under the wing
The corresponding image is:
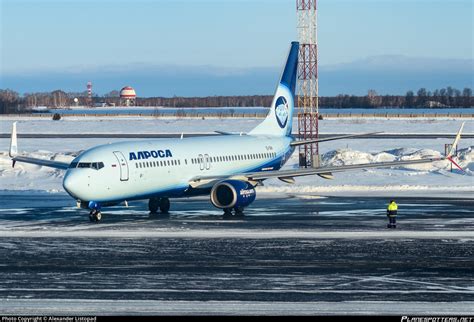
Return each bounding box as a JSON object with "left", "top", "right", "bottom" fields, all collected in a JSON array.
[{"left": 211, "top": 180, "right": 257, "bottom": 209}]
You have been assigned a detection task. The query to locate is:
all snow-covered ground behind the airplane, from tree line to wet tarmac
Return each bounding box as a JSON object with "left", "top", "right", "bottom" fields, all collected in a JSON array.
[{"left": 0, "top": 117, "right": 474, "bottom": 197}]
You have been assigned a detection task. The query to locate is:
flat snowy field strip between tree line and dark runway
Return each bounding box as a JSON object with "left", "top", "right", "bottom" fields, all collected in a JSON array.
[{"left": 0, "top": 116, "right": 474, "bottom": 134}]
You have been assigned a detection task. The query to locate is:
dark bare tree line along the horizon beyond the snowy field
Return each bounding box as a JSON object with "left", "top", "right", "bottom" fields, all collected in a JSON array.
[{"left": 0, "top": 86, "right": 474, "bottom": 114}]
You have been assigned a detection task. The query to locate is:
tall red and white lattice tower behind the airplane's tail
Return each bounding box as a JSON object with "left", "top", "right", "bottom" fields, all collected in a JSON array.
[{"left": 296, "top": 0, "right": 319, "bottom": 168}]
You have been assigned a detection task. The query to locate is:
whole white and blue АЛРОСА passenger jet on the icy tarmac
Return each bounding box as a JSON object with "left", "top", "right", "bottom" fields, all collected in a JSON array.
[{"left": 9, "top": 42, "right": 464, "bottom": 222}]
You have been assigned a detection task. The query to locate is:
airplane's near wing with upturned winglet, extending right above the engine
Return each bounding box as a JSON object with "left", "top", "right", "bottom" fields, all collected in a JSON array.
[{"left": 190, "top": 123, "right": 464, "bottom": 188}]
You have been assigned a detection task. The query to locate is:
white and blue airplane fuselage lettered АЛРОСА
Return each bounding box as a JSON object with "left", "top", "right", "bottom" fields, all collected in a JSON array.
[{"left": 63, "top": 135, "right": 294, "bottom": 203}]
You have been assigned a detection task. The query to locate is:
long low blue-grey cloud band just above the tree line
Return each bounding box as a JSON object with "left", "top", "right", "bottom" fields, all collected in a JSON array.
[{"left": 0, "top": 55, "right": 474, "bottom": 97}]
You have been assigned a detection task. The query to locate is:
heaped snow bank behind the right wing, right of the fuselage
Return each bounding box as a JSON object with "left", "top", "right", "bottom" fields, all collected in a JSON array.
[{"left": 257, "top": 146, "right": 474, "bottom": 197}]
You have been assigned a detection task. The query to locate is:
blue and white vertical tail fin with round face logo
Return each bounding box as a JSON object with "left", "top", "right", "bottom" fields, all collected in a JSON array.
[{"left": 248, "top": 41, "right": 299, "bottom": 136}]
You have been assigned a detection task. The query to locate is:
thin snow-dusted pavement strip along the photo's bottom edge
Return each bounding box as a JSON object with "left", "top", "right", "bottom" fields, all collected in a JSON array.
[{"left": 0, "top": 299, "right": 473, "bottom": 316}]
